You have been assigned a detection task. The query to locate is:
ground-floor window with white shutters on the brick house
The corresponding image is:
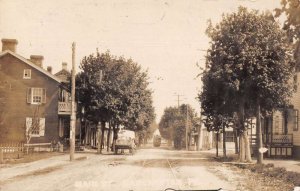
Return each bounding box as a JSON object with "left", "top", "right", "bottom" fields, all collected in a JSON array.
[{"left": 26, "top": 117, "right": 45, "bottom": 137}]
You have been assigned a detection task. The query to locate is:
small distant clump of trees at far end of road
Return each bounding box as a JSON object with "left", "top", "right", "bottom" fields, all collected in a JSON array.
[{"left": 159, "top": 104, "right": 199, "bottom": 149}]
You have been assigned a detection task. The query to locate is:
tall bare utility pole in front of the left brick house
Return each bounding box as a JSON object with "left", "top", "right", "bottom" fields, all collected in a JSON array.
[{"left": 70, "top": 42, "right": 76, "bottom": 161}]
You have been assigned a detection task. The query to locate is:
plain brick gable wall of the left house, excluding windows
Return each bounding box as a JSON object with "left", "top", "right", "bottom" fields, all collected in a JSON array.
[{"left": 0, "top": 54, "right": 60, "bottom": 143}]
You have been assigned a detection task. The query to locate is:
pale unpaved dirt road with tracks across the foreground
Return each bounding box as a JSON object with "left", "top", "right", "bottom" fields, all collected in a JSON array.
[{"left": 0, "top": 149, "right": 294, "bottom": 191}]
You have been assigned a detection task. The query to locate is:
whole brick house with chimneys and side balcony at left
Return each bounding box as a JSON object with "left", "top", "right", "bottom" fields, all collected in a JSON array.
[{"left": 0, "top": 39, "right": 71, "bottom": 143}]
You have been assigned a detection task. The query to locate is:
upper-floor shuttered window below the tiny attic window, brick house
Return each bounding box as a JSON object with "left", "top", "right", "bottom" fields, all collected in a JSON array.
[{"left": 27, "top": 88, "right": 46, "bottom": 104}]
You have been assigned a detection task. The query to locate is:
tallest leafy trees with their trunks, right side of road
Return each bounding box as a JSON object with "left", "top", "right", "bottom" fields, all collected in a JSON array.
[{"left": 199, "top": 5, "right": 299, "bottom": 163}]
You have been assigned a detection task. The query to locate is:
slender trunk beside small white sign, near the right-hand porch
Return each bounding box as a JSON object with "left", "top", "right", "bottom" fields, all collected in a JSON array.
[{"left": 256, "top": 102, "right": 263, "bottom": 164}]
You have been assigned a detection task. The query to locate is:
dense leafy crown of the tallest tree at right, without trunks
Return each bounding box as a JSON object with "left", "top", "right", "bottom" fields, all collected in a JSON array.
[{"left": 200, "top": 7, "right": 294, "bottom": 124}]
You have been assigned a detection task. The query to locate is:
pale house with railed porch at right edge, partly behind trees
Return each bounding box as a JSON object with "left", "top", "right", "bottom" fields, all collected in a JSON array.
[{"left": 262, "top": 45, "right": 300, "bottom": 159}]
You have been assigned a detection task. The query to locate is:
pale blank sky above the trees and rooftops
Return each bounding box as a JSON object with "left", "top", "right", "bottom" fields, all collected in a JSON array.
[{"left": 0, "top": 0, "right": 280, "bottom": 122}]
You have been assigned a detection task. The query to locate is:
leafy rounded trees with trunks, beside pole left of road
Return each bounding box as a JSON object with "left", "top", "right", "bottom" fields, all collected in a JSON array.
[{"left": 76, "top": 51, "right": 155, "bottom": 153}]
